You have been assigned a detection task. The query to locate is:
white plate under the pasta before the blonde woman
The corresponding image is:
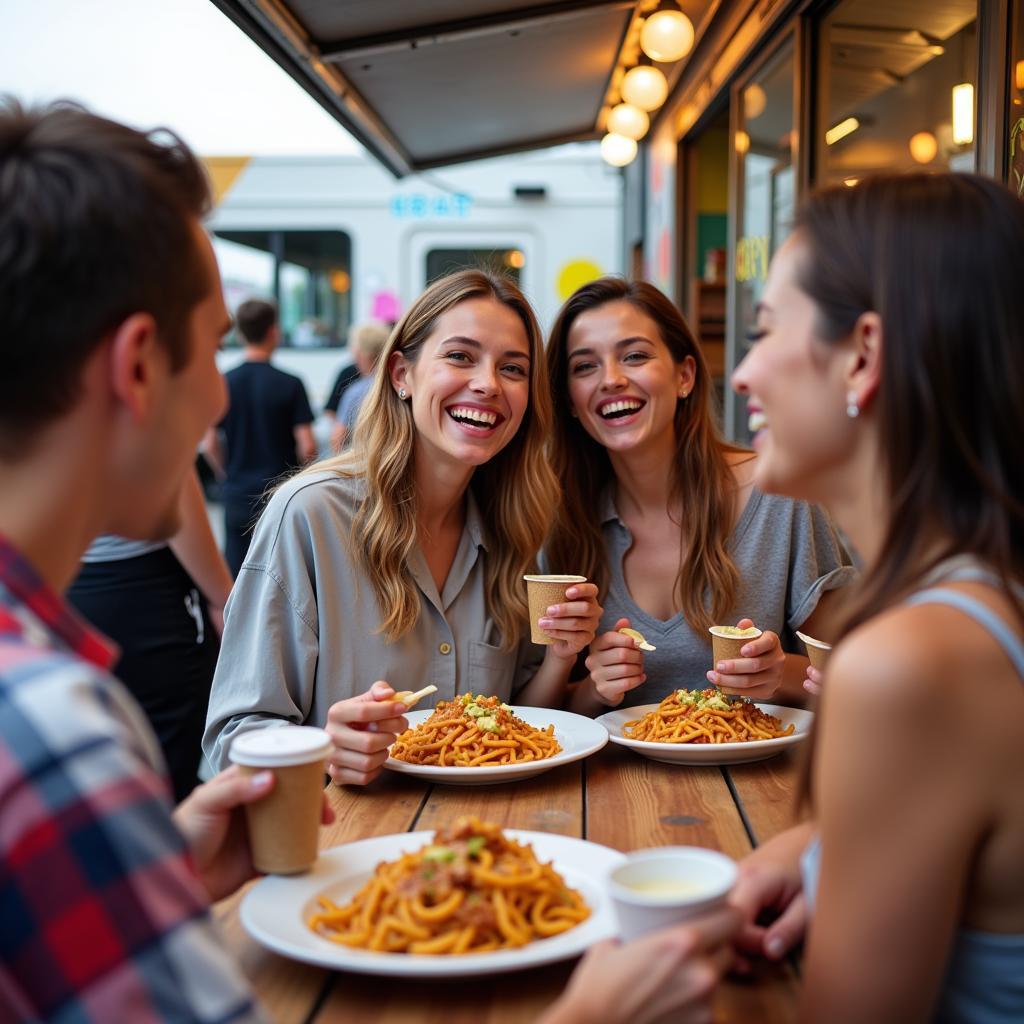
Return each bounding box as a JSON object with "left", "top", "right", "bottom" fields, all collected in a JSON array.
[{"left": 384, "top": 708, "right": 608, "bottom": 785}]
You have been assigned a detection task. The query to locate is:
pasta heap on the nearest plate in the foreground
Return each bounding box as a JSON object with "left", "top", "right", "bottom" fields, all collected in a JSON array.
[{"left": 309, "top": 817, "right": 590, "bottom": 954}]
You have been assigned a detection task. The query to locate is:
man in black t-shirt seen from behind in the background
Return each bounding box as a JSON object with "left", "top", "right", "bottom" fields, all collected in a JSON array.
[{"left": 203, "top": 299, "right": 316, "bottom": 577}]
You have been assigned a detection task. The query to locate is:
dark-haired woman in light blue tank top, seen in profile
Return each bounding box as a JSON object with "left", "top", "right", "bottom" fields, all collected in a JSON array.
[{"left": 733, "top": 174, "right": 1024, "bottom": 1024}]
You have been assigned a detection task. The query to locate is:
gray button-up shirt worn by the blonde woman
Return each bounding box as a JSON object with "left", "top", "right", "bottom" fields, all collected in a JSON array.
[{"left": 203, "top": 473, "right": 544, "bottom": 768}]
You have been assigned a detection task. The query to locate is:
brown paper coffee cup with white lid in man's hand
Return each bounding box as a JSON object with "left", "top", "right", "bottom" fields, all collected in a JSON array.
[{"left": 228, "top": 725, "right": 333, "bottom": 874}]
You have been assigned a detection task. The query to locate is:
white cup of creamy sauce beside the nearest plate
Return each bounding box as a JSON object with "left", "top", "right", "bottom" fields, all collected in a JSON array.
[{"left": 608, "top": 846, "right": 737, "bottom": 941}]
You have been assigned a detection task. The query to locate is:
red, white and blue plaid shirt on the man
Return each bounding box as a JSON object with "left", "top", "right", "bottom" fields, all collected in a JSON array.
[{"left": 0, "top": 537, "right": 262, "bottom": 1024}]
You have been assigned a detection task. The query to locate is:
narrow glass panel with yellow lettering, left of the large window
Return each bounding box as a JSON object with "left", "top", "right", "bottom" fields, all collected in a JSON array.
[{"left": 724, "top": 38, "right": 796, "bottom": 443}]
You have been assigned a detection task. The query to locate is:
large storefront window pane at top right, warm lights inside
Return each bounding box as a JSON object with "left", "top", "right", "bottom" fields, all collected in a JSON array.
[{"left": 814, "top": 0, "right": 978, "bottom": 184}]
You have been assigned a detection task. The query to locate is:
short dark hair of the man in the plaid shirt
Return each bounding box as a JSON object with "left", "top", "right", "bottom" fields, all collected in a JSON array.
[{"left": 0, "top": 98, "right": 210, "bottom": 459}]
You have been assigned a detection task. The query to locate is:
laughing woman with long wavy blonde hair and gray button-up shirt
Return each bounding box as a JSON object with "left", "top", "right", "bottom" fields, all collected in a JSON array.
[{"left": 204, "top": 270, "right": 601, "bottom": 783}]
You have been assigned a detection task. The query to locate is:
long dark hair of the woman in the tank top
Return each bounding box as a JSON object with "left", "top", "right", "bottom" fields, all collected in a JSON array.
[{"left": 795, "top": 174, "right": 1024, "bottom": 629}]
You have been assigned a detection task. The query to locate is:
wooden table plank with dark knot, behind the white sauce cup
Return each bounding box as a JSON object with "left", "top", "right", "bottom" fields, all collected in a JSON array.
[{"left": 587, "top": 743, "right": 751, "bottom": 857}]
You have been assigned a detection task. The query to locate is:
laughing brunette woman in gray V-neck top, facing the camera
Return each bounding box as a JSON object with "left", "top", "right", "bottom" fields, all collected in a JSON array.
[{"left": 547, "top": 278, "right": 853, "bottom": 713}]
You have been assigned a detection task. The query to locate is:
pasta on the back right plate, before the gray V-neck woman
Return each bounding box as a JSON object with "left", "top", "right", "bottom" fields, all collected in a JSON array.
[{"left": 623, "top": 687, "right": 794, "bottom": 743}]
